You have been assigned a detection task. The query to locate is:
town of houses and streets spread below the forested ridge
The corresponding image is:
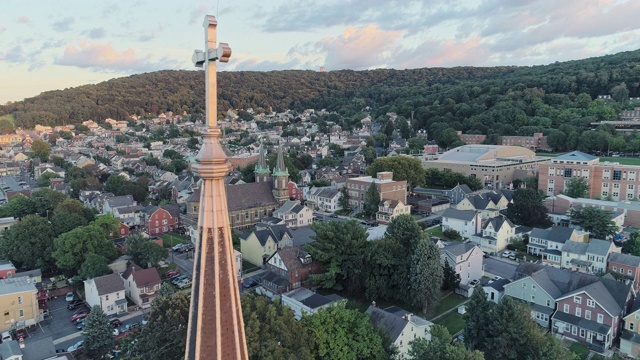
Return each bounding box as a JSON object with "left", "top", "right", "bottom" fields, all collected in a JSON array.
[{"left": 0, "top": 109, "right": 640, "bottom": 360}]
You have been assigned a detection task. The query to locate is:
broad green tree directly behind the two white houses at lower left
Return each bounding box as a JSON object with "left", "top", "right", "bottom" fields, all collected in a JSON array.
[{"left": 53, "top": 223, "right": 118, "bottom": 274}]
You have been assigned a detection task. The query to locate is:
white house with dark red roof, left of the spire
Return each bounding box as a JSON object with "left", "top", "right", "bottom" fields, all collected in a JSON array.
[{"left": 122, "top": 264, "right": 162, "bottom": 308}]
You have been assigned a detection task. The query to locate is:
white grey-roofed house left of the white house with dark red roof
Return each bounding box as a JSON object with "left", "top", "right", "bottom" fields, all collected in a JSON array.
[{"left": 84, "top": 274, "right": 127, "bottom": 316}]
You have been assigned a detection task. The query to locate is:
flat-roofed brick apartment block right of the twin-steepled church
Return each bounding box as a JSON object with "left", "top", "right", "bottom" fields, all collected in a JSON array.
[{"left": 345, "top": 171, "right": 407, "bottom": 209}]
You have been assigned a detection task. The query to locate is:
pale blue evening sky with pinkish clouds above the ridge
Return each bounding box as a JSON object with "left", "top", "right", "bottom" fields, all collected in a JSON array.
[{"left": 0, "top": 0, "right": 640, "bottom": 104}]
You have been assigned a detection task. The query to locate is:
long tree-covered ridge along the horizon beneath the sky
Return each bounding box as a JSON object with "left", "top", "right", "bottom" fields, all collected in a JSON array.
[{"left": 0, "top": 50, "right": 640, "bottom": 142}]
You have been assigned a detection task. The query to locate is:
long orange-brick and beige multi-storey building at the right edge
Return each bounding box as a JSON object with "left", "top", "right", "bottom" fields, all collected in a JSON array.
[{"left": 538, "top": 151, "right": 640, "bottom": 201}]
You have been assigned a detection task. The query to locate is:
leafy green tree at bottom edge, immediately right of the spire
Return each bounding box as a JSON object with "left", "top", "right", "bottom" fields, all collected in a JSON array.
[{"left": 242, "top": 294, "right": 315, "bottom": 360}]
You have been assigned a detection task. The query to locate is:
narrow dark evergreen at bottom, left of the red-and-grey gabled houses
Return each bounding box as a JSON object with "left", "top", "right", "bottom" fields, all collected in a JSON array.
[{"left": 464, "top": 286, "right": 493, "bottom": 351}]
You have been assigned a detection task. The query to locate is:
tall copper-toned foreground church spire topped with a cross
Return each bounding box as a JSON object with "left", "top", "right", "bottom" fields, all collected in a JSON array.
[{"left": 185, "top": 15, "right": 249, "bottom": 360}]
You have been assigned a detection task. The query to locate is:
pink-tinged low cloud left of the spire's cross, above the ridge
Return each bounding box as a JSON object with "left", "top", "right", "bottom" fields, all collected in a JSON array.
[{"left": 55, "top": 41, "right": 181, "bottom": 73}]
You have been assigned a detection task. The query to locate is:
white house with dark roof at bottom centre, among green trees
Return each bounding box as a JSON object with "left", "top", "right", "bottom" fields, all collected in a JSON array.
[{"left": 367, "top": 305, "right": 433, "bottom": 359}]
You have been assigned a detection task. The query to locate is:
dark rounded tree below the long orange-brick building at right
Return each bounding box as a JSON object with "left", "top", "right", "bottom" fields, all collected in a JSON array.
[{"left": 507, "top": 187, "right": 552, "bottom": 229}]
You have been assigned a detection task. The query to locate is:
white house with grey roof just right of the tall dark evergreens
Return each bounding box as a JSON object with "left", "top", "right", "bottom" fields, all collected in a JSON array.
[{"left": 440, "top": 242, "right": 484, "bottom": 285}]
